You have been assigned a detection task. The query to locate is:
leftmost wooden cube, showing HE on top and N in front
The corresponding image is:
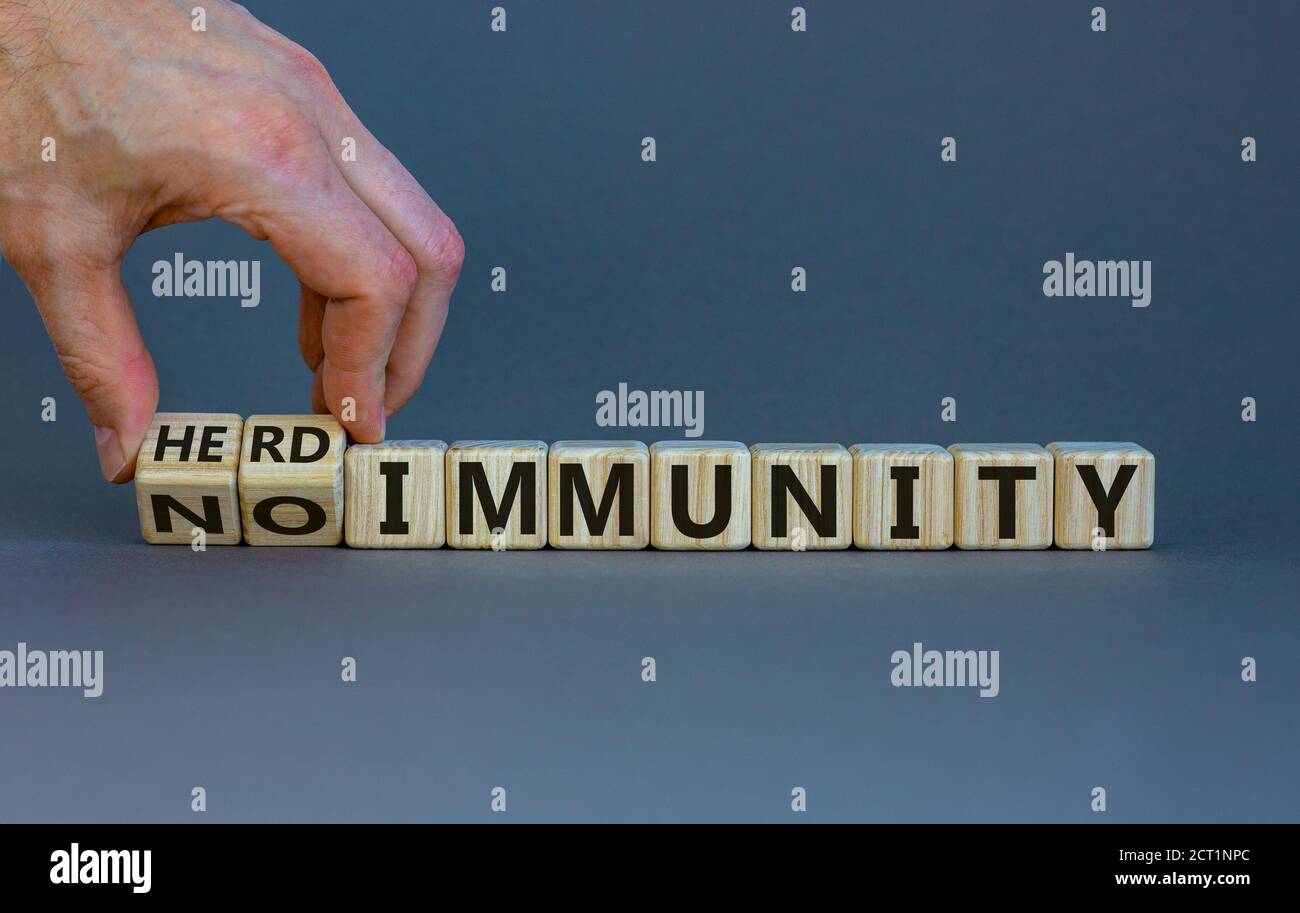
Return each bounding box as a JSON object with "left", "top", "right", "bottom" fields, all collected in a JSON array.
[{"left": 135, "top": 412, "right": 243, "bottom": 545}]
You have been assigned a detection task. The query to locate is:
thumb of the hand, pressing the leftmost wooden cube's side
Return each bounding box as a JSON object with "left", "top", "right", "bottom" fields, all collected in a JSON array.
[{"left": 23, "top": 264, "right": 159, "bottom": 483}]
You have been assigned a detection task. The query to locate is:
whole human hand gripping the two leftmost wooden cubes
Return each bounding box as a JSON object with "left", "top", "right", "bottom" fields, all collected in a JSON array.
[{"left": 0, "top": 0, "right": 464, "bottom": 483}]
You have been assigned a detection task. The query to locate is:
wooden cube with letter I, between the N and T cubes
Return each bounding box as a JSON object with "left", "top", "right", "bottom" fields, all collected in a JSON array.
[{"left": 849, "top": 443, "right": 953, "bottom": 549}]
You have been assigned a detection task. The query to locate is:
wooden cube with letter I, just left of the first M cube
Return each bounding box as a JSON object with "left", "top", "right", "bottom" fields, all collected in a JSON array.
[{"left": 343, "top": 441, "right": 447, "bottom": 549}]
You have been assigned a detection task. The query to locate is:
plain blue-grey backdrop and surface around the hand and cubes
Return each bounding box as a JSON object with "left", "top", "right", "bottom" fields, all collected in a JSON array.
[{"left": 0, "top": 0, "right": 1300, "bottom": 821}]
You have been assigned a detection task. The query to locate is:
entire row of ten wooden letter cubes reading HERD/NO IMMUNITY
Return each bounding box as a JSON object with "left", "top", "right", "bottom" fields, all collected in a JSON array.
[{"left": 135, "top": 414, "right": 1156, "bottom": 551}]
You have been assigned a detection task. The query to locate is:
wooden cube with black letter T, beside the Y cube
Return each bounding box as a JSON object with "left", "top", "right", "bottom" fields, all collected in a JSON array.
[{"left": 948, "top": 443, "right": 1053, "bottom": 549}]
